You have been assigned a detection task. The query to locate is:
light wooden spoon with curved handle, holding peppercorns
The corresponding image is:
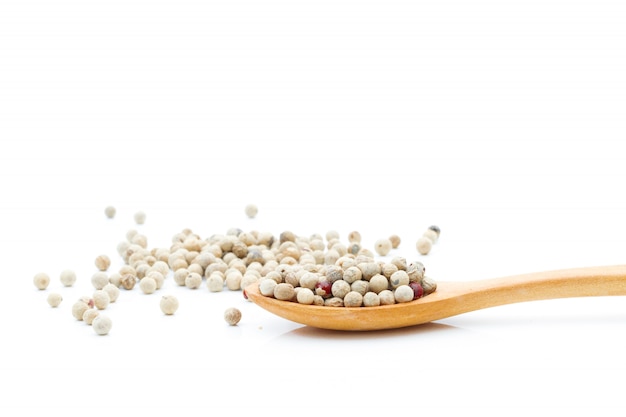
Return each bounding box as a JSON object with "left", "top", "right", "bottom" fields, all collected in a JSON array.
[{"left": 245, "top": 265, "right": 626, "bottom": 331}]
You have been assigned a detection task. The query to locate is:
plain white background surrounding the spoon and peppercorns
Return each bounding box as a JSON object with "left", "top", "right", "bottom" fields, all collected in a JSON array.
[{"left": 0, "top": 0, "right": 626, "bottom": 416}]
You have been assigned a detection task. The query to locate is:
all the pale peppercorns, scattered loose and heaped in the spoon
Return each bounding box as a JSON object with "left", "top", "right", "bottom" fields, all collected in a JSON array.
[{"left": 33, "top": 205, "right": 440, "bottom": 335}]
